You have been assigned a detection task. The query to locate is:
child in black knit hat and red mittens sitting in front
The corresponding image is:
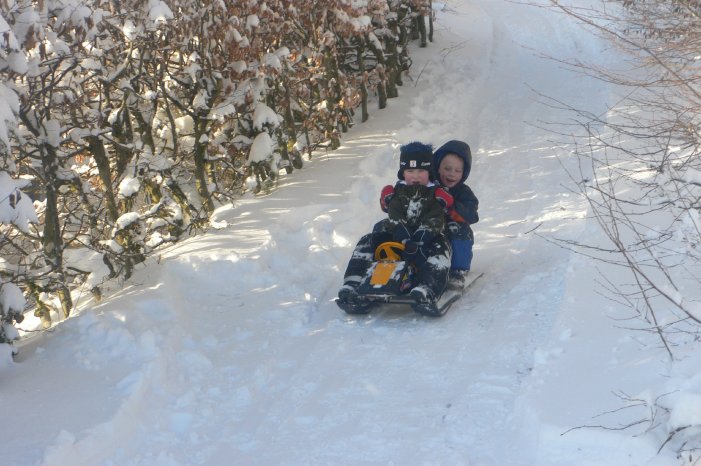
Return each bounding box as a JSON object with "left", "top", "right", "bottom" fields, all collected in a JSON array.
[{"left": 338, "top": 142, "right": 452, "bottom": 310}]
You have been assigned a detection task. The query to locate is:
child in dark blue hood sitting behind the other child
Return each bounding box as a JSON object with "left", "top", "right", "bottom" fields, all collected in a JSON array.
[{"left": 433, "top": 140, "right": 479, "bottom": 288}]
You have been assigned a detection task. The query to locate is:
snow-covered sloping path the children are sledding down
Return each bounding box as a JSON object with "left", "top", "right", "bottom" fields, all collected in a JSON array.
[{"left": 0, "top": 0, "right": 698, "bottom": 466}]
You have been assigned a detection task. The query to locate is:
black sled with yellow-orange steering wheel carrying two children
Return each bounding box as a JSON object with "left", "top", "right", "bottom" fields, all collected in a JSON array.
[{"left": 336, "top": 242, "right": 483, "bottom": 317}]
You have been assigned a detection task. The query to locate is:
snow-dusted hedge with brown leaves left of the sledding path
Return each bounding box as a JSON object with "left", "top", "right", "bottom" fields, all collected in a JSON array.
[{"left": 0, "top": 0, "right": 431, "bottom": 350}]
